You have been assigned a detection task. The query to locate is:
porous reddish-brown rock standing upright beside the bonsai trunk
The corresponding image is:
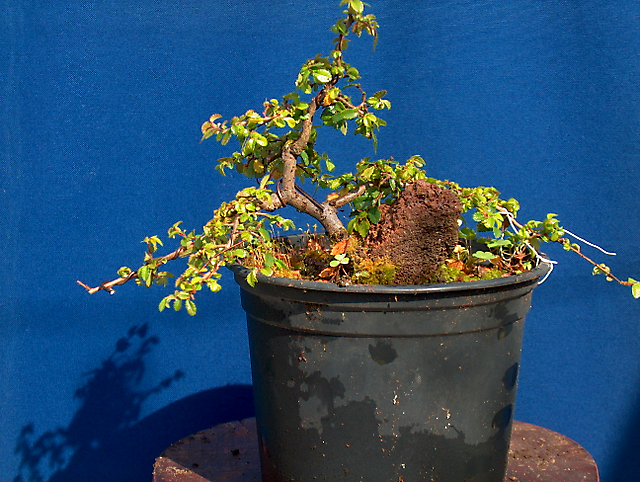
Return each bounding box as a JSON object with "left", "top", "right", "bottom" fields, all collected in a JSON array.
[{"left": 367, "top": 179, "right": 462, "bottom": 284}]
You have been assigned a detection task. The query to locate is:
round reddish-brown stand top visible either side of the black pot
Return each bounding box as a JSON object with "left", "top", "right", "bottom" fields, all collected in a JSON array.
[{"left": 153, "top": 418, "right": 599, "bottom": 482}]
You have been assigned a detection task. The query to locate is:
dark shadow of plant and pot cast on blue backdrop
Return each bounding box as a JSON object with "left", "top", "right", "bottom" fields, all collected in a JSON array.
[{"left": 13, "top": 324, "right": 253, "bottom": 482}]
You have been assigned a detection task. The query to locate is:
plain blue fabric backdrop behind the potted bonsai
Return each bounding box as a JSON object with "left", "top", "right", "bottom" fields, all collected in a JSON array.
[{"left": 0, "top": 0, "right": 640, "bottom": 482}]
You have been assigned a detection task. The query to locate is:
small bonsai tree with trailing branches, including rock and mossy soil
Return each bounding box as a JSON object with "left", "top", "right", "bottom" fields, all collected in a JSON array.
[{"left": 78, "top": 0, "right": 640, "bottom": 315}]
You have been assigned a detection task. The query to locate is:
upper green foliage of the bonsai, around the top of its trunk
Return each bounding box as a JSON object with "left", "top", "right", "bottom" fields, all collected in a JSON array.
[{"left": 201, "top": 0, "right": 391, "bottom": 192}]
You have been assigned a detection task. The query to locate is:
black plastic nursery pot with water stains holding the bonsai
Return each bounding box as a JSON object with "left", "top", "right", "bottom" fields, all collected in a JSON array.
[{"left": 232, "top": 258, "right": 548, "bottom": 482}]
